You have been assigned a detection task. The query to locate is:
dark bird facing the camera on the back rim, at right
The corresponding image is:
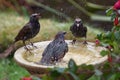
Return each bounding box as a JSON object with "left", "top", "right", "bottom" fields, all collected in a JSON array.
[{"left": 70, "top": 18, "right": 87, "bottom": 44}]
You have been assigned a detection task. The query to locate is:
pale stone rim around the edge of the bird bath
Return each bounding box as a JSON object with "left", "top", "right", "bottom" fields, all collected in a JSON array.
[{"left": 14, "top": 40, "right": 107, "bottom": 69}]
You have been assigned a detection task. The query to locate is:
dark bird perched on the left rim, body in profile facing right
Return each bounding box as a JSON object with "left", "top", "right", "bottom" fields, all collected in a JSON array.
[{"left": 0, "top": 13, "right": 40, "bottom": 57}]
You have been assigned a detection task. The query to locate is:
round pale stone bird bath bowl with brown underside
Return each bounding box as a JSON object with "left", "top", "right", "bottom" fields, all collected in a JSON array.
[{"left": 14, "top": 40, "right": 107, "bottom": 77}]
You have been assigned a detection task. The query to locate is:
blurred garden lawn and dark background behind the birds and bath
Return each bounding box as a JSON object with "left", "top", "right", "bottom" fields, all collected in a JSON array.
[{"left": 0, "top": 0, "right": 117, "bottom": 80}]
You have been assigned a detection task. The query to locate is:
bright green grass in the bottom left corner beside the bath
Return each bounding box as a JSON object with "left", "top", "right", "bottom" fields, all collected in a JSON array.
[{"left": 0, "top": 58, "right": 30, "bottom": 80}]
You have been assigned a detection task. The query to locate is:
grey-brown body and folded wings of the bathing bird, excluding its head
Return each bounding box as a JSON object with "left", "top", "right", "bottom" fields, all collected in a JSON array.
[{"left": 41, "top": 40, "right": 68, "bottom": 64}]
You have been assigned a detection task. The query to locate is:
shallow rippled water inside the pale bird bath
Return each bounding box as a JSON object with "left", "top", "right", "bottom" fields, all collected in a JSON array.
[{"left": 22, "top": 40, "right": 107, "bottom": 67}]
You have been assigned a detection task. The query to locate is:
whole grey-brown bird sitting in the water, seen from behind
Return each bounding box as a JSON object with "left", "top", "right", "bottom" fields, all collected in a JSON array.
[{"left": 40, "top": 32, "right": 68, "bottom": 65}]
